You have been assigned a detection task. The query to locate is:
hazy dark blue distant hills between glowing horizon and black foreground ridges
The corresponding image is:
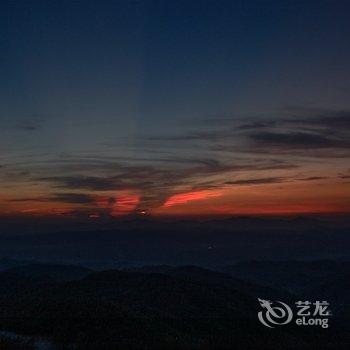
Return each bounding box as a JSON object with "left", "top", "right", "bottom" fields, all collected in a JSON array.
[{"left": 0, "top": 216, "right": 350, "bottom": 269}]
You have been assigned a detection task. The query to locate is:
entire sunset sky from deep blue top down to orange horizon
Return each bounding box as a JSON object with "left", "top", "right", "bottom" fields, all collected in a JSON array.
[{"left": 0, "top": 0, "right": 350, "bottom": 219}]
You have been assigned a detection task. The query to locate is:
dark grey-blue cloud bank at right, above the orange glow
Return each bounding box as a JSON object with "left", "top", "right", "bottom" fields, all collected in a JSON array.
[{"left": 142, "top": 107, "right": 350, "bottom": 158}]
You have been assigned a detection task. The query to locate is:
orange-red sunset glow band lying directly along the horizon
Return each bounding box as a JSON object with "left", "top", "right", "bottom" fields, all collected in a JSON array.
[{"left": 0, "top": 181, "right": 350, "bottom": 219}]
